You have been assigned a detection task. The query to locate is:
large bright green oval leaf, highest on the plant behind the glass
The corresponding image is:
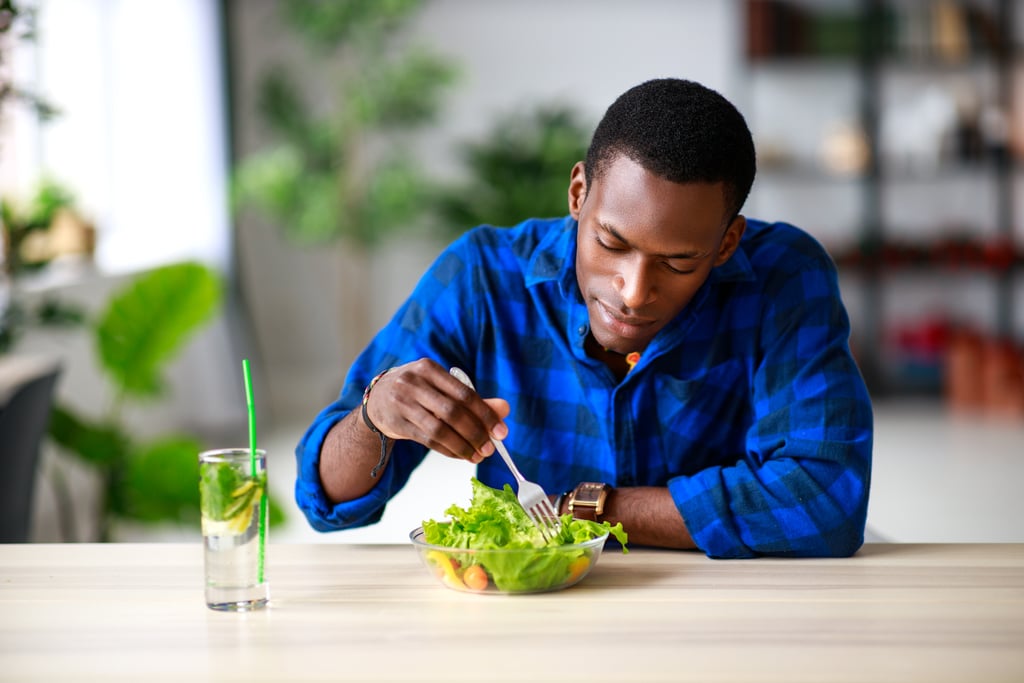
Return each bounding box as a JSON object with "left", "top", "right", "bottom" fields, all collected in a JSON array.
[{"left": 95, "top": 262, "right": 221, "bottom": 396}]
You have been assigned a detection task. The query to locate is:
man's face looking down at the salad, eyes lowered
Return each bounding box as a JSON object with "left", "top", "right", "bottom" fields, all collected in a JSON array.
[{"left": 569, "top": 156, "right": 745, "bottom": 353}]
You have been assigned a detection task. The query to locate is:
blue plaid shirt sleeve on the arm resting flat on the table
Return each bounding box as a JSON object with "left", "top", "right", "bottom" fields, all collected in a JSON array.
[{"left": 669, "top": 248, "right": 873, "bottom": 558}]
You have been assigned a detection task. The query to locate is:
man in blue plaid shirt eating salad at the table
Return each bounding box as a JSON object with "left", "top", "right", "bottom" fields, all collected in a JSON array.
[{"left": 296, "top": 79, "right": 872, "bottom": 558}]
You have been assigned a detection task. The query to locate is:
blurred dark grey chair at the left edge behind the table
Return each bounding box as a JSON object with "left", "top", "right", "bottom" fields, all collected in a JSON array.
[{"left": 0, "top": 359, "right": 60, "bottom": 543}]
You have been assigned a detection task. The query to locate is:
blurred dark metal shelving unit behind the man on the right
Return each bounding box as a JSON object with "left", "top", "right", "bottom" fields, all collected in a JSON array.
[{"left": 746, "top": 0, "right": 1024, "bottom": 395}]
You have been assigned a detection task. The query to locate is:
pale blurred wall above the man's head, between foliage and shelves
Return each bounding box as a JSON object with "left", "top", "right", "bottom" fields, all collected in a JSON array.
[{"left": 407, "top": 0, "right": 743, "bottom": 175}]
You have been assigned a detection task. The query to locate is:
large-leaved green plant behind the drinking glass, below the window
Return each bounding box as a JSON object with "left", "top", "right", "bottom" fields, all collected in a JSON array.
[{"left": 49, "top": 262, "right": 283, "bottom": 541}]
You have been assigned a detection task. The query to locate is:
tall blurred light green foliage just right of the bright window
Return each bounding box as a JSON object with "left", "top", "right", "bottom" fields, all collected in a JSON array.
[{"left": 232, "top": 0, "right": 455, "bottom": 248}]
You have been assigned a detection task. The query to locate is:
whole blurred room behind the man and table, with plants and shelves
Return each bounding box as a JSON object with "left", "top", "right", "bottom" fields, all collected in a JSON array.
[{"left": 0, "top": 0, "right": 1024, "bottom": 543}]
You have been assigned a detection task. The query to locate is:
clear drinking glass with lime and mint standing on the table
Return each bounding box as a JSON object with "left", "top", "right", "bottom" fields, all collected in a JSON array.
[{"left": 199, "top": 449, "right": 270, "bottom": 611}]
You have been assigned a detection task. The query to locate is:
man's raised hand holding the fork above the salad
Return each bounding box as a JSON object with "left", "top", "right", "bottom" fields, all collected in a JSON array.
[{"left": 367, "top": 358, "right": 510, "bottom": 463}]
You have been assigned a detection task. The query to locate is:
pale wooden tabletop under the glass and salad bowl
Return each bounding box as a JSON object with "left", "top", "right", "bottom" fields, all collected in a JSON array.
[{"left": 0, "top": 542, "right": 1024, "bottom": 683}]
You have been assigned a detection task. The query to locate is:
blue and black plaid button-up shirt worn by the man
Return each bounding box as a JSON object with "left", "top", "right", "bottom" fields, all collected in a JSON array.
[{"left": 295, "top": 217, "right": 872, "bottom": 558}]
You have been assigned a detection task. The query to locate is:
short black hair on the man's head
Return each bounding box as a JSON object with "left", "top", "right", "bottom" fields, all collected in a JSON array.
[{"left": 584, "top": 78, "right": 757, "bottom": 221}]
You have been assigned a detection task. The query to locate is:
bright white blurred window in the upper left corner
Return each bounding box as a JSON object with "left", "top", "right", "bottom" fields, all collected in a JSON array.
[{"left": 0, "top": 0, "right": 230, "bottom": 273}]
